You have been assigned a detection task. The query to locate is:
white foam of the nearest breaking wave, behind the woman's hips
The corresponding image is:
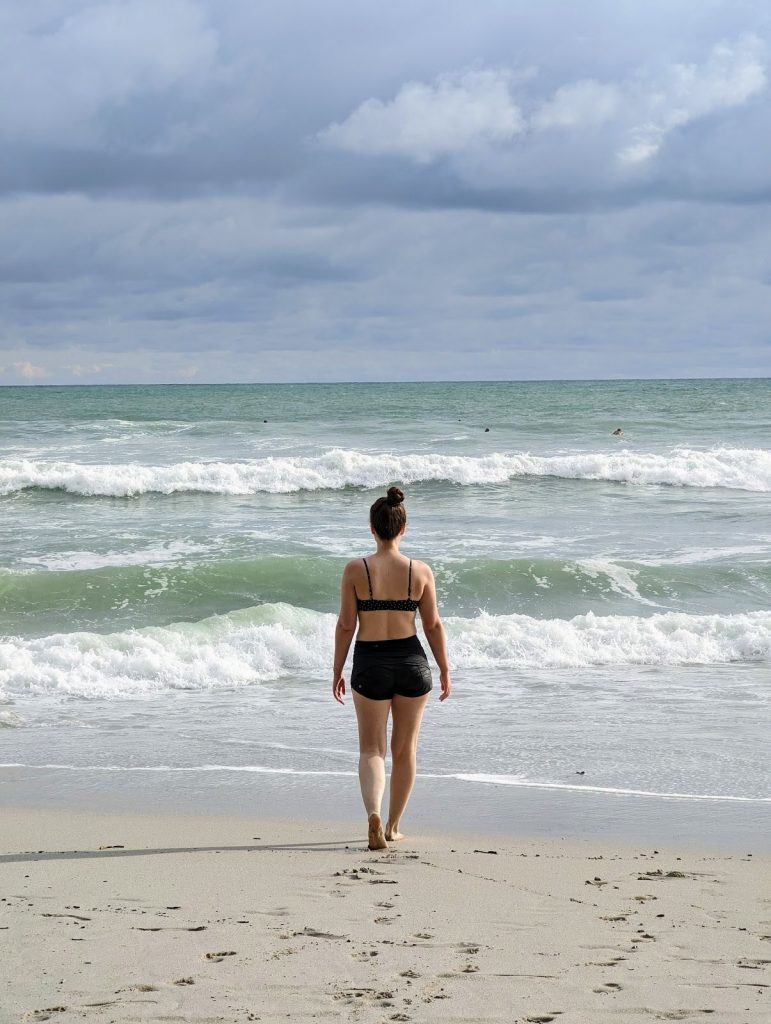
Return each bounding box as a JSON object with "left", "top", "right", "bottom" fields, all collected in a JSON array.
[{"left": 0, "top": 604, "right": 771, "bottom": 699}]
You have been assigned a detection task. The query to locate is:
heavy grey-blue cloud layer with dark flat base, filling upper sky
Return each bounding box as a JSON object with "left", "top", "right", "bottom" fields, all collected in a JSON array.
[{"left": 0, "top": 0, "right": 771, "bottom": 211}]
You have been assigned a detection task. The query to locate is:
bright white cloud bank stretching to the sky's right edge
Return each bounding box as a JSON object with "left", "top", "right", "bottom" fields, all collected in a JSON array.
[{"left": 317, "top": 34, "right": 767, "bottom": 196}]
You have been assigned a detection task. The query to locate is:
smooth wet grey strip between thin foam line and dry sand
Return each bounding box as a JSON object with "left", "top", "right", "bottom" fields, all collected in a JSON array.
[{"left": 0, "top": 768, "right": 771, "bottom": 855}]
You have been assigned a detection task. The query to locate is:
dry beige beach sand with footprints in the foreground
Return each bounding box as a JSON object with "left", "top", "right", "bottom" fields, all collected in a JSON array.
[{"left": 0, "top": 807, "right": 771, "bottom": 1024}]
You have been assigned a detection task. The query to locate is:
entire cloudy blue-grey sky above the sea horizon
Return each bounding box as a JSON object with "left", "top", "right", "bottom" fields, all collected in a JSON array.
[{"left": 0, "top": 0, "right": 771, "bottom": 384}]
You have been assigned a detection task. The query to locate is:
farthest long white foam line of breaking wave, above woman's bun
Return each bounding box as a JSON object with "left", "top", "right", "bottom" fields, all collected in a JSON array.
[{"left": 0, "top": 447, "right": 771, "bottom": 497}]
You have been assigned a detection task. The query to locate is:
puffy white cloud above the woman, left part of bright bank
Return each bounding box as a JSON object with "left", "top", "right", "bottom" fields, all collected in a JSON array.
[{"left": 318, "top": 69, "right": 524, "bottom": 164}]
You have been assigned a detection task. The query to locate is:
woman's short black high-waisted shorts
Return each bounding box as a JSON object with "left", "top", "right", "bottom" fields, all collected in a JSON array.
[{"left": 351, "top": 636, "right": 431, "bottom": 700}]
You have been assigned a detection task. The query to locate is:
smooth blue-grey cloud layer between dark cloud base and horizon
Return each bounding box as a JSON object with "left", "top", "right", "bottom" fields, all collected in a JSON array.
[{"left": 0, "top": 190, "right": 771, "bottom": 383}]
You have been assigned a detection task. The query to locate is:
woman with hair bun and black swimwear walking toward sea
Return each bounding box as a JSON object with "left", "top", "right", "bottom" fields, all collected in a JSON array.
[{"left": 332, "top": 487, "right": 452, "bottom": 850}]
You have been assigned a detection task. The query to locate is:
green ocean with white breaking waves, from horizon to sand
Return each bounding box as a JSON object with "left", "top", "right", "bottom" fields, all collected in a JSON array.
[{"left": 0, "top": 380, "right": 771, "bottom": 836}]
